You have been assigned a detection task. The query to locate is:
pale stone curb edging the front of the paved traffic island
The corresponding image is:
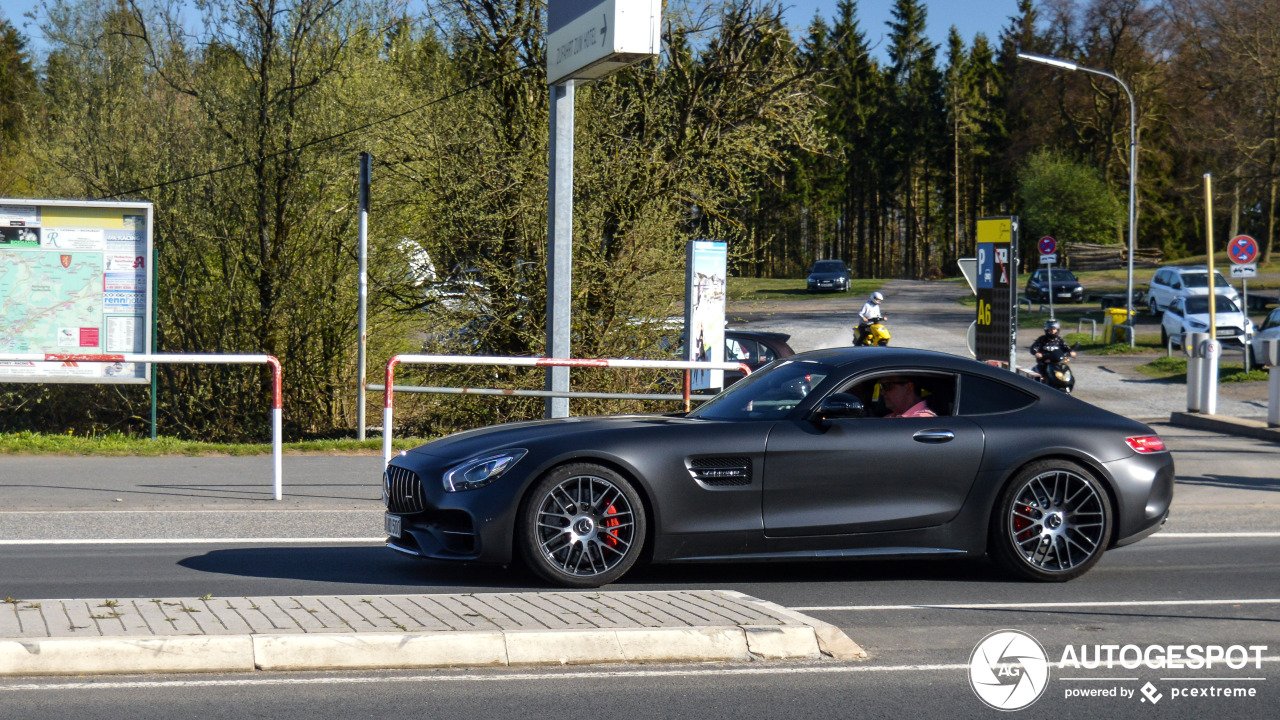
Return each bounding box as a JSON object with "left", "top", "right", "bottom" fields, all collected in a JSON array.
[{"left": 0, "top": 625, "right": 867, "bottom": 676}]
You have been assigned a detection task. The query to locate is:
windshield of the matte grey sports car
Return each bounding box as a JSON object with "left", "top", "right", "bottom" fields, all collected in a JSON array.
[{"left": 689, "top": 360, "right": 832, "bottom": 420}]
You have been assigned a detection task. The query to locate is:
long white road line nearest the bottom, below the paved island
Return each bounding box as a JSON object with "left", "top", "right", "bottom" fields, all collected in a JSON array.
[{"left": 0, "top": 656, "right": 1280, "bottom": 692}]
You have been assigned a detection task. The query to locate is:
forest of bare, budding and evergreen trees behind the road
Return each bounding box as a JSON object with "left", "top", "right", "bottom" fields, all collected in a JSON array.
[{"left": 0, "top": 0, "right": 1280, "bottom": 439}]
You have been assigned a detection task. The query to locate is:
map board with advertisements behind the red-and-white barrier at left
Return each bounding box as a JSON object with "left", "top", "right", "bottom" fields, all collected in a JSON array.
[{"left": 0, "top": 199, "right": 154, "bottom": 383}]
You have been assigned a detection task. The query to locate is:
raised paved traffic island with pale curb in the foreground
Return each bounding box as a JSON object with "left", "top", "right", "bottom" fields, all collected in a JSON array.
[{"left": 0, "top": 591, "right": 865, "bottom": 676}]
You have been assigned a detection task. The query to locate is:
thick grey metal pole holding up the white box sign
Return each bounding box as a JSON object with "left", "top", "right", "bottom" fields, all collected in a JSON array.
[{"left": 545, "top": 81, "right": 573, "bottom": 418}]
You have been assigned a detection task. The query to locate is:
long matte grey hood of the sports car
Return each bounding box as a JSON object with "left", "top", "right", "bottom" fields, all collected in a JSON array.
[{"left": 410, "top": 415, "right": 699, "bottom": 460}]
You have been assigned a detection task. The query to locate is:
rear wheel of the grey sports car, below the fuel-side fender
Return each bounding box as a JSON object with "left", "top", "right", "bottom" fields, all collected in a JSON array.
[{"left": 988, "top": 460, "right": 1112, "bottom": 583}]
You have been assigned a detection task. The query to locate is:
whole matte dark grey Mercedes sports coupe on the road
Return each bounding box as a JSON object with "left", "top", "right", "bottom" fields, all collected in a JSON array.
[{"left": 384, "top": 347, "right": 1174, "bottom": 587}]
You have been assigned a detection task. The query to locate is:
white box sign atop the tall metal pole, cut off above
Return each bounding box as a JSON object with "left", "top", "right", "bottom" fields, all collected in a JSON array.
[{"left": 547, "top": 0, "right": 662, "bottom": 85}]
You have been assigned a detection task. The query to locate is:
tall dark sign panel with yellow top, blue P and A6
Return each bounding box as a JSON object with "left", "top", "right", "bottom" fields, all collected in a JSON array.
[{"left": 975, "top": 218, "right": 1018, "bottom": 368}]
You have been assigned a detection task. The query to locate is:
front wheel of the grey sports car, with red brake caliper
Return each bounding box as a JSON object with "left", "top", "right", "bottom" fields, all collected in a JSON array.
[{"left": 517, "top": 462, "right": 648, "bottom": 588}]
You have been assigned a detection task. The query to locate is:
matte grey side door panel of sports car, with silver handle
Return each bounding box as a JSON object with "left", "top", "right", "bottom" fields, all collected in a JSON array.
[{"left": 763, "top": 368, "right": 984, "bottom": 537}]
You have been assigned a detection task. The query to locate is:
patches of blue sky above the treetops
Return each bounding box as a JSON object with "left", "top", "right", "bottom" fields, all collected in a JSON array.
[{"left": 3, "top": 0, "right": 1018, "bottom": 64}]
